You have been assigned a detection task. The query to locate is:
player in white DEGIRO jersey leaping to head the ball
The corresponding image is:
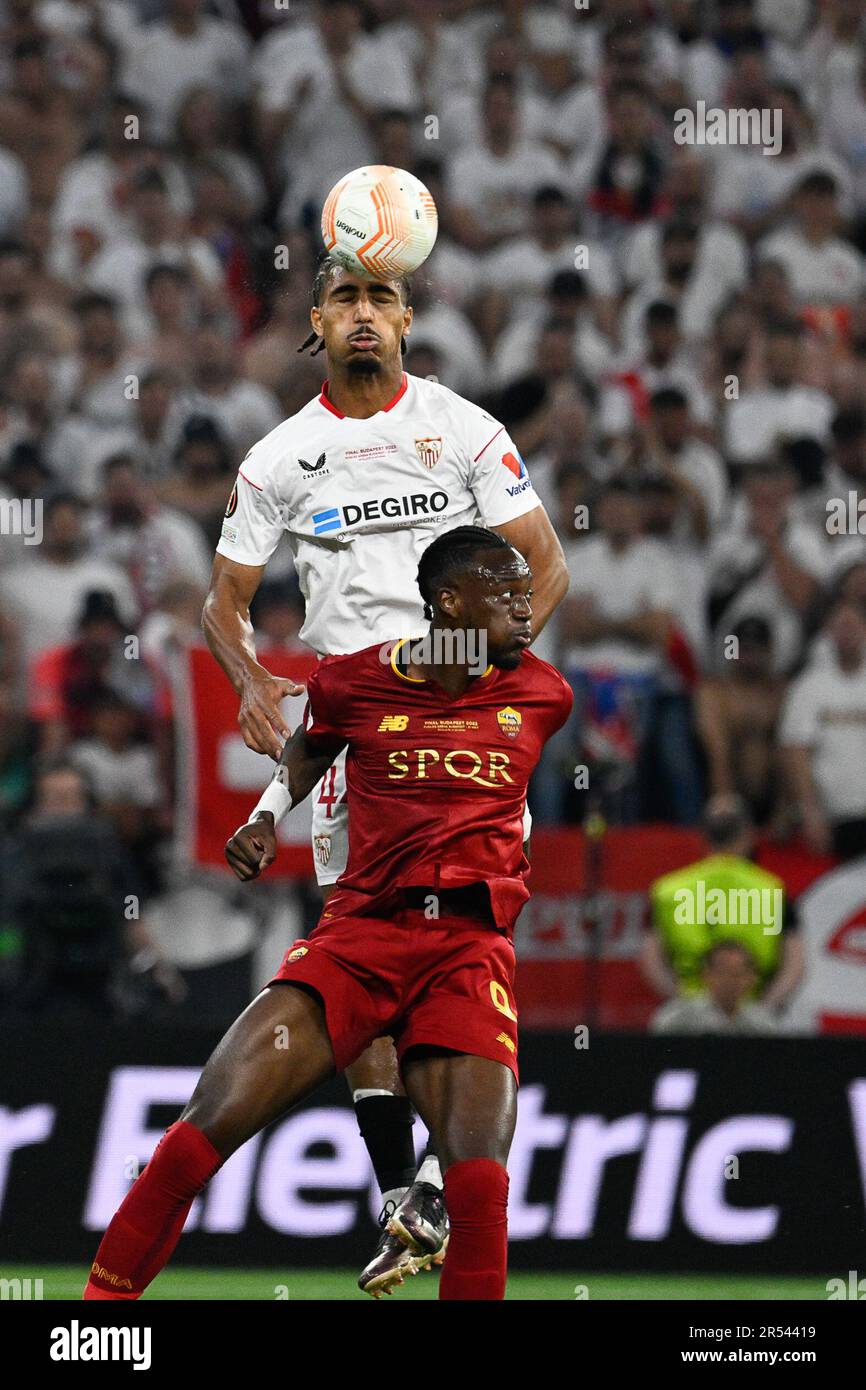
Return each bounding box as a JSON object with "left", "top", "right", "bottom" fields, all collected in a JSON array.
[{"left": 202, "top": 257, "right": 569, "bottom": 1295}]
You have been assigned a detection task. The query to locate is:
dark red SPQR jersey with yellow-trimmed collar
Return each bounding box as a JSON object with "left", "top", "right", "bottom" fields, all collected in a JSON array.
[{"left": 307, "top": 644, "right": 573, "bottom": 931}]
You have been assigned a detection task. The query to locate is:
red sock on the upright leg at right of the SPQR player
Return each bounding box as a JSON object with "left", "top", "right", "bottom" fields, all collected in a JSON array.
[{"left": 439, "top": 1158, "right": 509, "bottom": 1300}]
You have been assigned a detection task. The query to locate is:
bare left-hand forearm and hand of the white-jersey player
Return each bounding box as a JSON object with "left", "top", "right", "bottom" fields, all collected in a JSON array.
[{"left": 202, "top": 555, "right": 303, "bottom": 759}]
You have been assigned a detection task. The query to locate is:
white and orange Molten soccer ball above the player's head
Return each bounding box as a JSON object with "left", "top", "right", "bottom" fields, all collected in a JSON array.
[{"left": 321, "top": 164, "right": 439, "bottom": 279}]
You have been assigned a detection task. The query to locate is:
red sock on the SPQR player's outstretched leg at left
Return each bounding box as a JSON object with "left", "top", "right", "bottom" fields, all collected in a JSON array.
[{"left": 83, "top": 1120, "right": 222, "bottom": 1298}]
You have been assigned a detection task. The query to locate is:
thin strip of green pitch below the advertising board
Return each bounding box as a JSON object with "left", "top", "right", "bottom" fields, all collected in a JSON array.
[{"left": 10, "top": 1265, "right": 827, "bottom": 1302}]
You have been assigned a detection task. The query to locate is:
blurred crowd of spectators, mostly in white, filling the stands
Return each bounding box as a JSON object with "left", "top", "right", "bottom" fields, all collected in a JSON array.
[{"left": 0, "top": 0, "right": 866, "bottom": 1023}]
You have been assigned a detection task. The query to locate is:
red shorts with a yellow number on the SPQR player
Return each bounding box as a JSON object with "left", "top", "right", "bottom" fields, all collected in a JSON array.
[{"left": 270, "top": 908, "right": 517, "bottom": 1080}]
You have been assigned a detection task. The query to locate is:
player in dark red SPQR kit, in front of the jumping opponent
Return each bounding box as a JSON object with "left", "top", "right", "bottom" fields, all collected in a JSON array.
[{"left": 85, "top": 527, "right": 571, "bottom": 1300}]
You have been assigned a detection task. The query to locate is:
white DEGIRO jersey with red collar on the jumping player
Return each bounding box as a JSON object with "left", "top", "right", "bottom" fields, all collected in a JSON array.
[{"left": 217, "top": 373, "right": 541, "bottom": 656}]
